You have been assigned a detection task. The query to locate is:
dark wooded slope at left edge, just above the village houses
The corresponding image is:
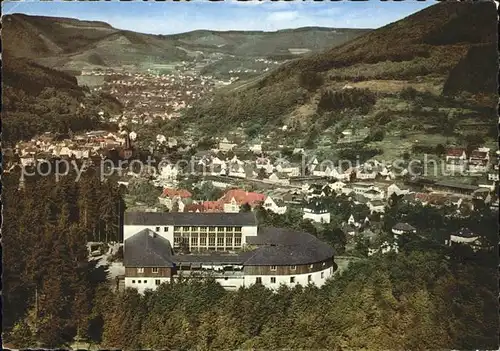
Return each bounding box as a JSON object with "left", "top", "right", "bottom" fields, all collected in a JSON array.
[{"left": 2, "top": 55, "right": 122, "bottom": 145}]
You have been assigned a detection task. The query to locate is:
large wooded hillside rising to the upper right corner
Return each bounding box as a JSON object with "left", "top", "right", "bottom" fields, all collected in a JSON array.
[{"left": 187, "top": 2, "right": 498, "bottom": 138}]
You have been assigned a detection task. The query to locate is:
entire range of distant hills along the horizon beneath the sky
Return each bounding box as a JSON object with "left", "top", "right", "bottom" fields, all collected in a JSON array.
[{"left": 2, "top": 14, "right": 368, "bottom": 70}]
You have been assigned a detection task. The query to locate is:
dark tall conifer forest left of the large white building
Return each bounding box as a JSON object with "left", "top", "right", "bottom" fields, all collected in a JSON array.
[{"left": 2, "top": 168, "right": 124, "bottom": 348}]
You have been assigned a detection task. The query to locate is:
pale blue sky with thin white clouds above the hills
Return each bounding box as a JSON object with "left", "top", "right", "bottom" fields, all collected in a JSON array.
[{"left": 2, "top": 0, "right": 435, "bottom": 34}]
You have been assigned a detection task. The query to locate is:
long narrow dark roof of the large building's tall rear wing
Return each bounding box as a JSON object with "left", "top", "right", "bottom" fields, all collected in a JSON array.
[{"left": 124, "top": 212, "right": 257, "bottom": 226}]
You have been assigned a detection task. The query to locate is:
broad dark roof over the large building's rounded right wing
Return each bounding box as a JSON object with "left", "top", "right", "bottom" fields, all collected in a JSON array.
[{"left": 244, "top": 227, "right": 333, "bottom": 266}]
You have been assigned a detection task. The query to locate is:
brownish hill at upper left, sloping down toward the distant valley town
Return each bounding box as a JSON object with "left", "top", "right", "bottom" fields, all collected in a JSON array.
[{"left": 2, "top": 14, "right": 191, "bottom": 71}]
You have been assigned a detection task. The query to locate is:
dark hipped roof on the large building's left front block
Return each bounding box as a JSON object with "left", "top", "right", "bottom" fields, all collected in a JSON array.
[{"left": 123, "top": 229, "right": 173, "bottom": 267}]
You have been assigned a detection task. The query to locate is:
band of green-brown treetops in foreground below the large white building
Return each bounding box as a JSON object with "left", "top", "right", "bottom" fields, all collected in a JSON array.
[{"left": 34, "top": 247, "right": 498, "bottom": 350}]
